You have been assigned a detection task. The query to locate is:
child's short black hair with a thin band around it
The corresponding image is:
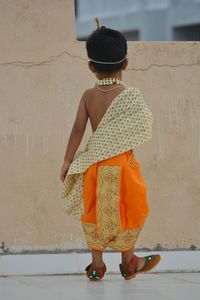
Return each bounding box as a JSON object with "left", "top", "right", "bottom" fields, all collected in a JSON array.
[{"left": 86, "top": 26, "right": 127, "bottom": 73}]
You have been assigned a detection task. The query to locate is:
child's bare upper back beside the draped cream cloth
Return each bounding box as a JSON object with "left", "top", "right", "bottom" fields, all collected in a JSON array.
[{"left": 85, "top": 85, "right": 126, "bottom": 132}]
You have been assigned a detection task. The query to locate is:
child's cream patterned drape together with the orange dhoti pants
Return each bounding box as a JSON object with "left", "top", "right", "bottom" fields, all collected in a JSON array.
[{"left": 61, "top": 87, "right": 153, "bottom": 251}]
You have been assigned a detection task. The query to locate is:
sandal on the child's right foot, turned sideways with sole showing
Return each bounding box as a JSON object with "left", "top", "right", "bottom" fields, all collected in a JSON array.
[{"left": 119, "top": 254, "right": 161, "bottom": 280}]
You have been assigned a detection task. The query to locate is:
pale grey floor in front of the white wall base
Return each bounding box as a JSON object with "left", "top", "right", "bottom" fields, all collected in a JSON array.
[{"left": 0, "top": 273, "right": 200, "bottom": 300}]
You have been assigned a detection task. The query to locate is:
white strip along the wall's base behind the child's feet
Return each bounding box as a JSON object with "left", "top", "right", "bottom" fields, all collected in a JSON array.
[{"left": 0, "top": 250, "right": 200, "bottom": 276}]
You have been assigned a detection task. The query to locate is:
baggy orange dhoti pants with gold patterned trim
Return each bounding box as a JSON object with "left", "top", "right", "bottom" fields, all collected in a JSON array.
[{"left": 80, "top": 149, "right": 149, "bottom": 251}]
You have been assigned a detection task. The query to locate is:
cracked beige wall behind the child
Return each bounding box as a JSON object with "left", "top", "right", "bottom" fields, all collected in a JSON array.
[{"left": 0, "top": 0, "right": 200, "bottom": 252}]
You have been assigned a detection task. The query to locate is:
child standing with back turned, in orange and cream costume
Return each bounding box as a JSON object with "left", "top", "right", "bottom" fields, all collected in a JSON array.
[{"left": 60, "top": 18, "right": 160, "bottom": 280}]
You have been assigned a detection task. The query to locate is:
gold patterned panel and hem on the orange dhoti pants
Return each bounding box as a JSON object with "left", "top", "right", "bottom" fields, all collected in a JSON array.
[{"left": 82, "top": 165, "right": 142, "bottom": 251}]
